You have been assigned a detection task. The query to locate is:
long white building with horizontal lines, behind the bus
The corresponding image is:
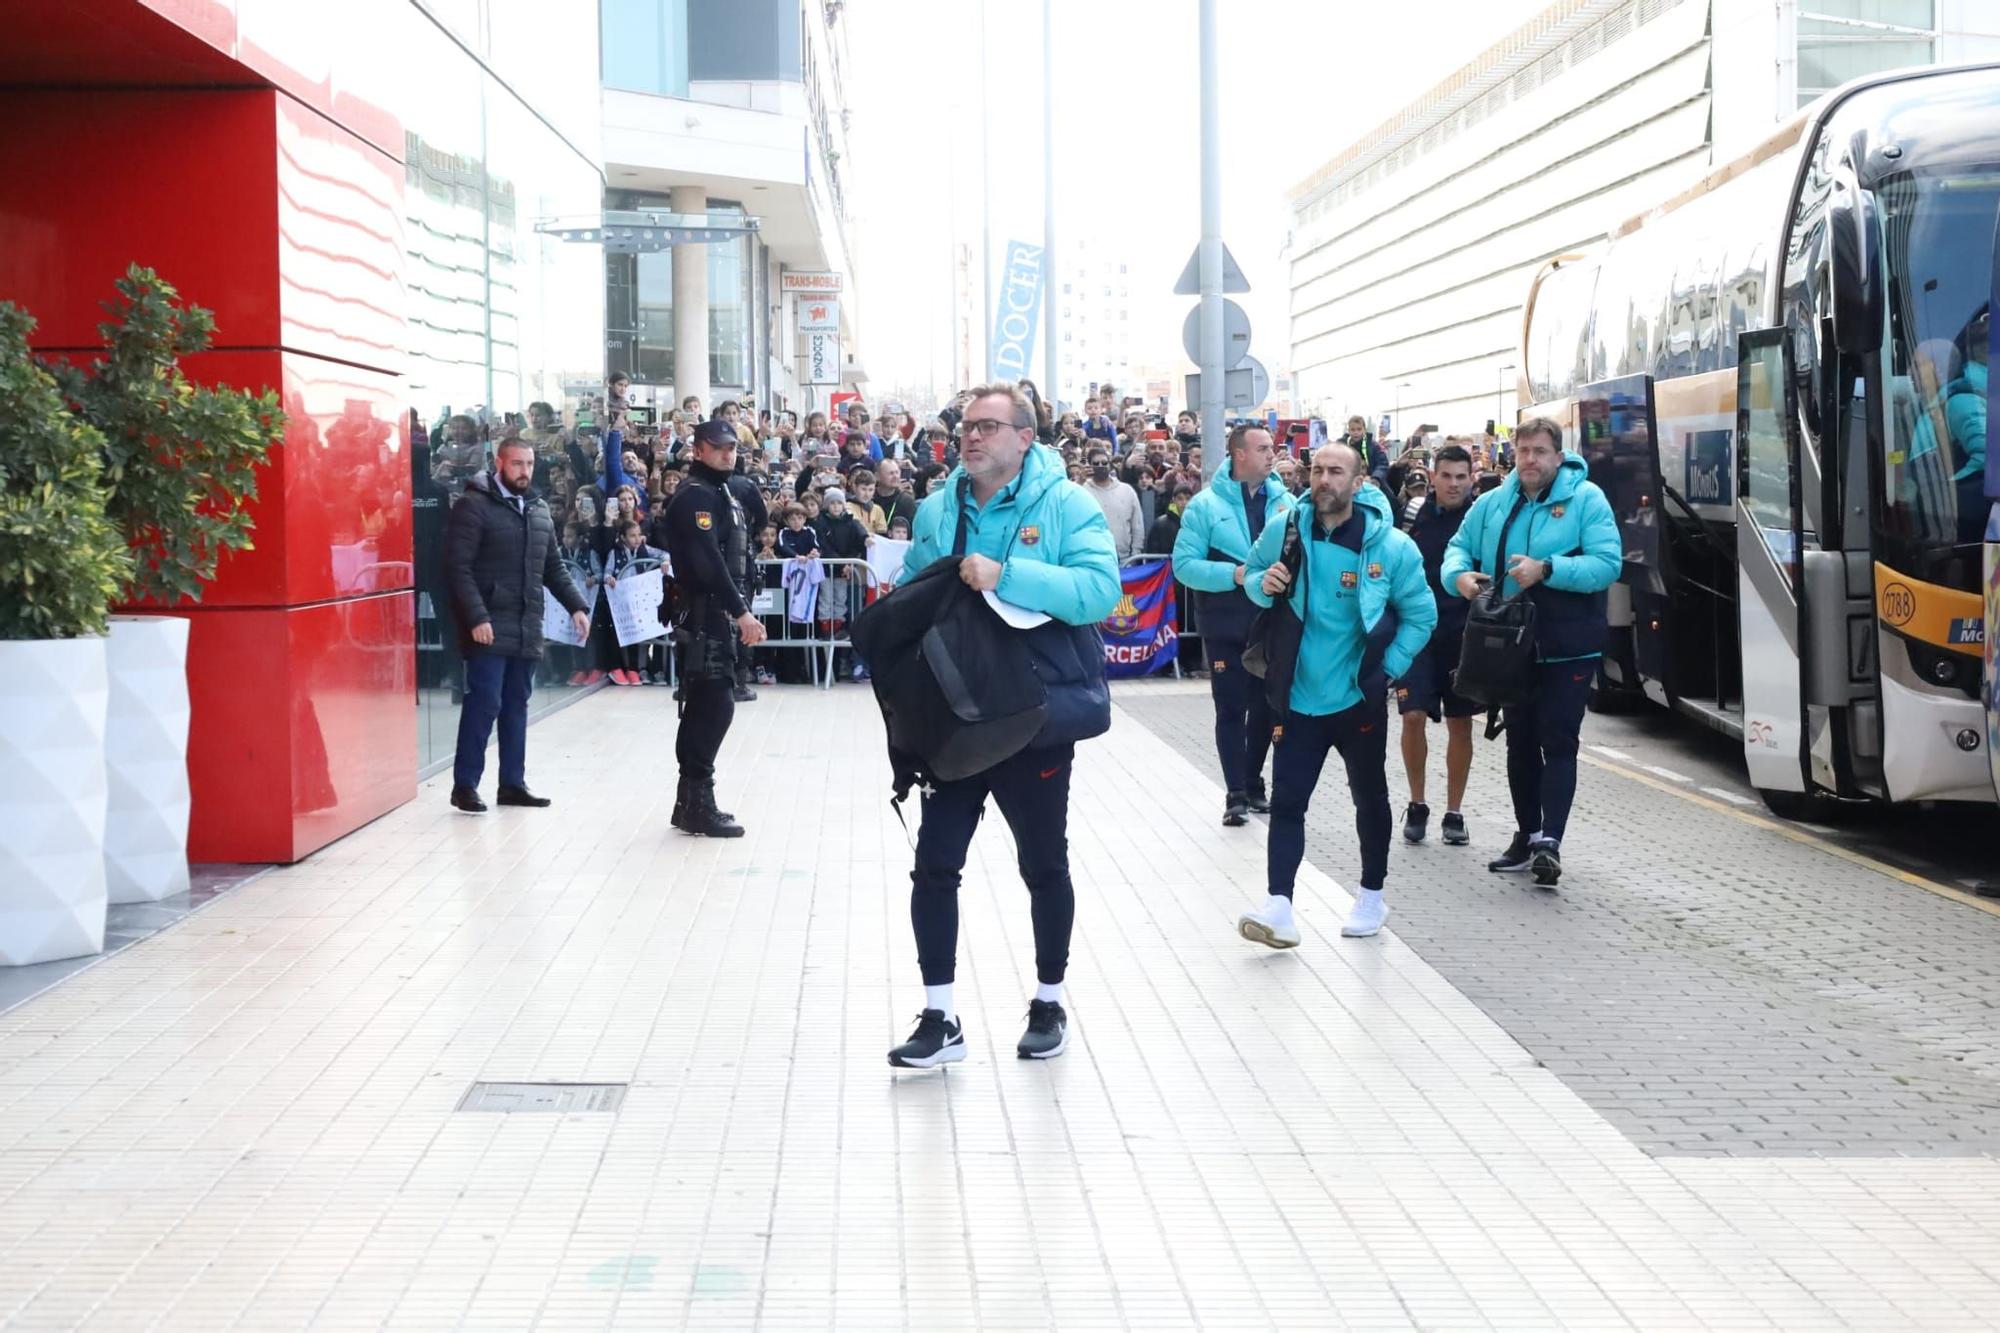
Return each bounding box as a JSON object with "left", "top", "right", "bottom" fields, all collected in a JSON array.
[{"left": 1290, "top": 0, "right": 2000, "bottom": 436}]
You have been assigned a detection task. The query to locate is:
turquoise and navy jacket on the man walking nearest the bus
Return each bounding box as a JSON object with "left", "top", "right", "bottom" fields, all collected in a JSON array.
[{"left": 1438, "top": 450, "right": 1624, "bottom": 662}]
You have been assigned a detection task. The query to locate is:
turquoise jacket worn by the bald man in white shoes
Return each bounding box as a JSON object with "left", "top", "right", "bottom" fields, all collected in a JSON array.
[{"left": 1244, "top": 484, "right": 1438, "bottom": 717}]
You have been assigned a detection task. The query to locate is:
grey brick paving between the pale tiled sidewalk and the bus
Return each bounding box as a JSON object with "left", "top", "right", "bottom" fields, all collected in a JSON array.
[{"left": 1118, "top": 683, "right": 2000, "bottom": 1157}]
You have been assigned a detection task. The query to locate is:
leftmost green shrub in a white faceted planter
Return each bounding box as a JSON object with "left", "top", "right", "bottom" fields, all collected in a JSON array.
[{"left": 0, "top": 302, "right": 132, "bottom": 965}]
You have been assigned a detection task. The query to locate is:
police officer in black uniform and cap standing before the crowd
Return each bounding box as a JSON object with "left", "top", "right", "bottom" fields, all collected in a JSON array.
[{"left": 666, "top": 420, "right": 764, "bottom": 839}]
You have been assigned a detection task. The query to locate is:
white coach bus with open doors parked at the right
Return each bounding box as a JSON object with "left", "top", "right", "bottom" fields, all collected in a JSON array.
[{"left": 1518, "top": 64, "right": 2000, "bottom": 815}]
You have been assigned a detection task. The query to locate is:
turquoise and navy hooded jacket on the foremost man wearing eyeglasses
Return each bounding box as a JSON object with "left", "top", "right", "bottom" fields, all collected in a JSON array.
[{"left": 902, "top": 444, "right": 1124, "bottom": 747}]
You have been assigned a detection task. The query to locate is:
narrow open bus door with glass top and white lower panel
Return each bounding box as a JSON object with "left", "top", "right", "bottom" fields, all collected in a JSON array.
[{"left": 1736, "top": 328, "right": 1810, "bottom": 795}]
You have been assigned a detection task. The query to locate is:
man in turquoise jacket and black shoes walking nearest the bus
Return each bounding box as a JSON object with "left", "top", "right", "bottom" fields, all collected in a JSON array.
[{"left": 1438, "top": 416, "right": 1624, "bottom": 889}]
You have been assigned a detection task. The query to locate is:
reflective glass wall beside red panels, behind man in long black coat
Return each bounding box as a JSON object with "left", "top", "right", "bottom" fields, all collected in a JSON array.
[{"left": 400, "top": 0, "right": 604, "bottom": 771}]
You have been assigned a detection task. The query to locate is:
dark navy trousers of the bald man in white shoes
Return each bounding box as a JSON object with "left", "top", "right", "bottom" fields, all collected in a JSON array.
[{"left": 1264, "top": 695, "right": 1390, "bottom": 899}]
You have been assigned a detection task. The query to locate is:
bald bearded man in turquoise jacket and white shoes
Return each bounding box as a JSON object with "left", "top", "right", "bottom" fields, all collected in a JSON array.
[{"left": 1236, "top": 442, "right": 1438, "bottom": 949}]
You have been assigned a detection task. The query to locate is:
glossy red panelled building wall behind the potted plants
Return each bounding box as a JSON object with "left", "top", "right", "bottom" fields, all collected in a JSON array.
[{"left": 0, "top": 72, "right": 416, "bottom": 861}]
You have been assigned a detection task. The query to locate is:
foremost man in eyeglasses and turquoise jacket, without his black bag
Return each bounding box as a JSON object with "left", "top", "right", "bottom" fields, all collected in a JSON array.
[{"left": 888, "top": 384, "right": 1120, "bottom": 1069}]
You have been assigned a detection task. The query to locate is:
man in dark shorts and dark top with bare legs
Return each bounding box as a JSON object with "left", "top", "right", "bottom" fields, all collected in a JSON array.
[{"left": 1396, "top": 444, "right": 1478, "bottom": 847}]
